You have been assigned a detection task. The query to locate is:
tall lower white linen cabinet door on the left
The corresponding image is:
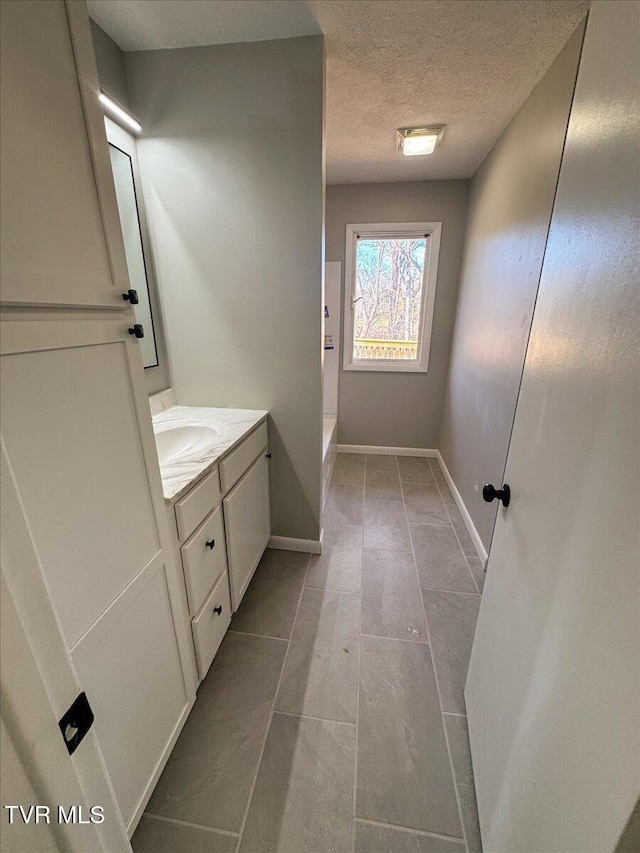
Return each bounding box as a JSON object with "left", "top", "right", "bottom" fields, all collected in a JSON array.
[{"left": 0, "top": 313, "right": 194, "bottom": 828}]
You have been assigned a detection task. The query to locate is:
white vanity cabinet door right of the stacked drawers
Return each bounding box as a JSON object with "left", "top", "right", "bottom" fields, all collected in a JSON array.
[{"left": 224, "top": 454, "right": 271, "bottom": 611}]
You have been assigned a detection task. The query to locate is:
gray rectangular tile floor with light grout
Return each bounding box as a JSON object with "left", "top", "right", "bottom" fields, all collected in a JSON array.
[{"left": 133, "top": 454, "right": 484, "bottom": 853}]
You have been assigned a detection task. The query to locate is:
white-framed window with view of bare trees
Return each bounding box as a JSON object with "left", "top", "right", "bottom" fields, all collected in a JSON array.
[{"left": 344, "top": 222, "right": 442, "bottom": 373}]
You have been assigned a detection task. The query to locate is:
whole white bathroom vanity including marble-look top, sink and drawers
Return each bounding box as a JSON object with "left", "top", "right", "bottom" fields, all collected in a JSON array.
[{"left": 150, "top": 391, "right": 271, "bottom": 680}]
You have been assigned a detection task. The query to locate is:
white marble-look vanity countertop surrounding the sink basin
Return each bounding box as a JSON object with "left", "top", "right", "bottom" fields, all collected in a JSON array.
[{"left": 151, "top": 395, "right": 269, "bottom": 503}]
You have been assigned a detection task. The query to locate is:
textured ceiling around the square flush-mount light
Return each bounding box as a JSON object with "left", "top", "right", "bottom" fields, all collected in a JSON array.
[{"left": 88, "top": 0, "right": 589, "bottom": 184}]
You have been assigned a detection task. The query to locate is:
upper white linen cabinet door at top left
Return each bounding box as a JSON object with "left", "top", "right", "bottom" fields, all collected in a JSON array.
[{"left": 0, "top": 0, "right": 128, "bottom": 308}]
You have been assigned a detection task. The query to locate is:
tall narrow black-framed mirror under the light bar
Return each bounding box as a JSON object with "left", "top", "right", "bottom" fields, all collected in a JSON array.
[{"left": 109, "top": 139, "right": 158, "bottom": 368}]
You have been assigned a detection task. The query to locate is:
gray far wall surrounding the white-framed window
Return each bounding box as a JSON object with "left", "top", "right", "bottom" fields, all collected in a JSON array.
[{"left": 326, "top": 180, "right": 469, "bottom": 448}]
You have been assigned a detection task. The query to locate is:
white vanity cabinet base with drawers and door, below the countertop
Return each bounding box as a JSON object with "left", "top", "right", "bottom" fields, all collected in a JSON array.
[{"left": 168, "top": 420, "right": 271, "bottom": 680}]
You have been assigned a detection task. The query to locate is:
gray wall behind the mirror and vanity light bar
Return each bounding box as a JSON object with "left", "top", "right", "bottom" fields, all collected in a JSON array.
[{"left": 91, "top": 21, "right": 171, "bottom": 394}]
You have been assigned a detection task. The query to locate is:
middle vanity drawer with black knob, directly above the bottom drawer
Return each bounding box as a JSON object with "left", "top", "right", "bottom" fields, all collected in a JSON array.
[{"left": 180, "top": 506, "right": 227, "bottom": 616}]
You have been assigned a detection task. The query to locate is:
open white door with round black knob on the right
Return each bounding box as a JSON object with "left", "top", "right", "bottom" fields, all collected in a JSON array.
[{"left": 465, "top": 0, "right": 640, "bottom": 853}]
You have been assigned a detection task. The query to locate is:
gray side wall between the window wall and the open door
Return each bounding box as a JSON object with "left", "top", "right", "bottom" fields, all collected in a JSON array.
[{"left": 439, "top": 25, "right": 584, "bottom": 548}]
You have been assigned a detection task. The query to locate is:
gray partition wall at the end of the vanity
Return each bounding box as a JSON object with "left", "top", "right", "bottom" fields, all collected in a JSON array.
[{"left": 125, "top": 36, "right": 324, "bottom": 539}]
